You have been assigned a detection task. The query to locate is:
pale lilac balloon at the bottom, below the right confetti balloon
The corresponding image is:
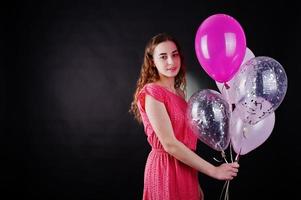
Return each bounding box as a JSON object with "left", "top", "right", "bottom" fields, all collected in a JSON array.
[{"left": 230, "top": 110, "right": 275, "bottom": 155}]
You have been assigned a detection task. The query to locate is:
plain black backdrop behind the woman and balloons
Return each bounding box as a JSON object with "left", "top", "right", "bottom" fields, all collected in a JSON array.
[{"left": 5, "top": 1, "right": 301, "bottom": 200}]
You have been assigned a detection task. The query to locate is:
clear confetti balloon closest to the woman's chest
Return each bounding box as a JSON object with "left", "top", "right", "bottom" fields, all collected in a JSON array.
[{"left": 186, "top": 89, "right": 230, "bottom": 151}]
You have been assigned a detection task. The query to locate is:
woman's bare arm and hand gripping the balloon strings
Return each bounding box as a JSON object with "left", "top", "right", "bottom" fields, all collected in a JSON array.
[{"left": 145, "top": 95, "right": 238, "bottom": 180}]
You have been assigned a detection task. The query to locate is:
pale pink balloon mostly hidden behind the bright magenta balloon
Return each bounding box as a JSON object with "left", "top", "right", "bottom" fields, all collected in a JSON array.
[{"left": 215, "top": 47, "right": 255, "bottom": 104}]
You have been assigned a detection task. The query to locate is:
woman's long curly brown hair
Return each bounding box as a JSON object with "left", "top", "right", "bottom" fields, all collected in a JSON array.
[{"left": 129, "top": 33, "right": 186, "bottom": 123}]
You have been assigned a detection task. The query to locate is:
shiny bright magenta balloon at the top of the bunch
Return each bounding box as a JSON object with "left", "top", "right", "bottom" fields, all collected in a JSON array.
[{"left": 195, "top": 14, "right": 246, "bottom": 83}]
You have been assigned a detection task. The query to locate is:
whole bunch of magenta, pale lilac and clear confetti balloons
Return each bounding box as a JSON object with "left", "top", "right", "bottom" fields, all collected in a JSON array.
[{"left": 187, "top": 14, "right": 287, "bottom": 155}]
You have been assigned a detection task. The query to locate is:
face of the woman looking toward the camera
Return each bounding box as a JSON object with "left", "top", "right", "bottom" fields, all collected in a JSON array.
[{"left": 153, "top": 41, "right": 181, "bottom": 78}]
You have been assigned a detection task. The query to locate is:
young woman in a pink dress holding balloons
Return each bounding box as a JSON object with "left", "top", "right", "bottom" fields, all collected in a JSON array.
[{"left": 130, "top": 33, "right": 239, "bottom": 200}]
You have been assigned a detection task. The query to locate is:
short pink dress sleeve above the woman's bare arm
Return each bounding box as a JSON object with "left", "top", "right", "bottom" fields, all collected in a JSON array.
[{"left": 138, "top": 84, "right": 166, "bottom": 111}]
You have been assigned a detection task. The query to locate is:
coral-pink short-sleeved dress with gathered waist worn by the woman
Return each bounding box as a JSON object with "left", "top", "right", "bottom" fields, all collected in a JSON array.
[{"left": 138, "top": 83, "right": 201, "bottom": 200}]
